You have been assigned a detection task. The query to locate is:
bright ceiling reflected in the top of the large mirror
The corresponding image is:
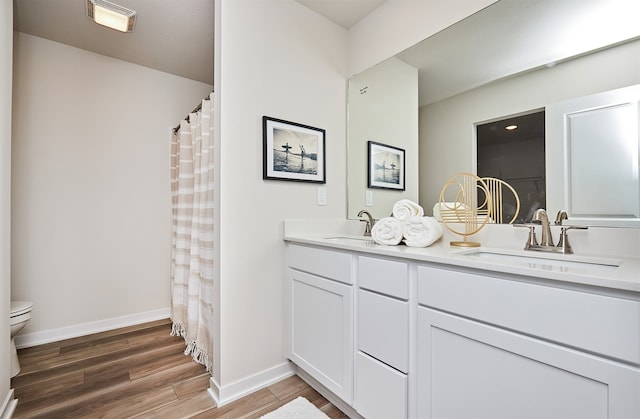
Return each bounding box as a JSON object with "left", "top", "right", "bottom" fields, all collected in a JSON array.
[{"left": 397, "top": 0, "right": 640, "bottom": 107}]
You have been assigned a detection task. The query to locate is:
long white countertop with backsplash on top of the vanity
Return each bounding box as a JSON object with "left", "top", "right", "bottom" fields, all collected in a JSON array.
[{"left": 284, "top": 220, "right": 640, "bottom": 293}]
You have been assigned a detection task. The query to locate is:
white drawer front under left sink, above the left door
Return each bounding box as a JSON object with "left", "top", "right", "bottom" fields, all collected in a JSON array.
[{"left": 287, "top": 244, "right": 353, "bottom": 285}]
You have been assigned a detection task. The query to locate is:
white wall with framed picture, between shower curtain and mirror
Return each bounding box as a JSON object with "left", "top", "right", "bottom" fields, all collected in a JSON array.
[{"left": 214, "top": 0, "right": 348, "bottom": 387}]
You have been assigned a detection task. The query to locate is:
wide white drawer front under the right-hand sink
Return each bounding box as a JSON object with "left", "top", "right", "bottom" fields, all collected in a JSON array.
[{"left": 418, "top": 266, "right": 640, "bottom": 365}]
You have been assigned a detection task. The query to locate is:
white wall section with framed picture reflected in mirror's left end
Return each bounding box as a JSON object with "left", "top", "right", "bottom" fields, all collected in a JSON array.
[{"left": 347, "top": 58, "right": 418, "bottom": 219}]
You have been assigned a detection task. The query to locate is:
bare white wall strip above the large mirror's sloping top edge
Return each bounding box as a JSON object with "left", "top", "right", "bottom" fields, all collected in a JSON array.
[{"left": 349, "top": 0, "right": 496, "bottom": 75}]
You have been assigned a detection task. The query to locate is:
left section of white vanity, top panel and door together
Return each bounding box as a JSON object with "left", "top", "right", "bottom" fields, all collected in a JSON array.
[{"left": 286, "top": 245, "right": 354, "bottom": 404}]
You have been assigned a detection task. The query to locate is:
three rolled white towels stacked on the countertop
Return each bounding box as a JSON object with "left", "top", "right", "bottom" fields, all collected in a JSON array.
[{"left": 371, "top": 199, "right": 442, "bottom": 247}]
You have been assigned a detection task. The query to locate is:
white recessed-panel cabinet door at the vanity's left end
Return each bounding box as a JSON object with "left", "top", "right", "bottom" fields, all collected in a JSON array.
[{"left": 288, "top": 269, "right": 353, "bottom": 403}]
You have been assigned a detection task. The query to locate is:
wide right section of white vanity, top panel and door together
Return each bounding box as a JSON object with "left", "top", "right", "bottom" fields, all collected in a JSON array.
[{"left": 416, "top": 266, "right": 640, "bottom": 419}]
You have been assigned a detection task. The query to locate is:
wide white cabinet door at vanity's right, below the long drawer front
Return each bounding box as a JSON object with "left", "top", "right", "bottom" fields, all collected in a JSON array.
[{"left": 417, "top": 308, "right": 640, "bottom": 419}]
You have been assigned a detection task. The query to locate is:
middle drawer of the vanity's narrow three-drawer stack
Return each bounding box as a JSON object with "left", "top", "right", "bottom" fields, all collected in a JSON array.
[{"left": 357, "top": 290, "right": 409, "bottom": 373}]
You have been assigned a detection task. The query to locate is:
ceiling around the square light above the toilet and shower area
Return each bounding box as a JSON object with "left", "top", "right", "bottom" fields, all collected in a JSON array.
[{"left": 13, "top": 0, "right": 213, "bottom": 85}]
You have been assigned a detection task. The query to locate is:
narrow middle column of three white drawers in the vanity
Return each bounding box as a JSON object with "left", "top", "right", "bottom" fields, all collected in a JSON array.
[{"left": 355, "top": 256, "right": 410, "bottom": 419}]
